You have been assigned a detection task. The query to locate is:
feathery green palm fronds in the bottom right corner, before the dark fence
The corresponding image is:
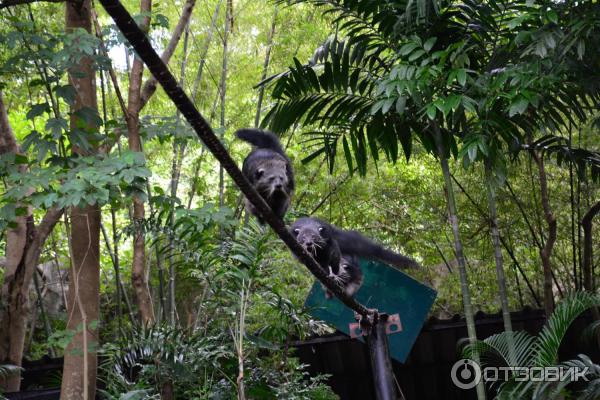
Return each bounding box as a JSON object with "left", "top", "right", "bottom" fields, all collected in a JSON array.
[{"left": 463, "top": 292, "right": 600, "bottom": 399}]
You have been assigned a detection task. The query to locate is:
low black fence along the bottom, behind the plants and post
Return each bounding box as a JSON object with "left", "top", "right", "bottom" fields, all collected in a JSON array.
[{"left": 6, "top": 309, "right": 600, "bottom": 400}]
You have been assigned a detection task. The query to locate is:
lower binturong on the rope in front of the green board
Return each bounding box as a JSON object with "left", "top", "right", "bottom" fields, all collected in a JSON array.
[{"left": 290, "top": 217, "right": 419, "bottom": 298}]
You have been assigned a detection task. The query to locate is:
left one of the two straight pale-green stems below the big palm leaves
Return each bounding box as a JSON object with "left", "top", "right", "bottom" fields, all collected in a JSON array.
[{"left": 434, "top": 125, "right": 485, "bottom": 400}]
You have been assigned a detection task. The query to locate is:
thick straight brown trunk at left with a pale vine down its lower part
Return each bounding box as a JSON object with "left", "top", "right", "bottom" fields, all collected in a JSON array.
[{"left": 60, "top": 0, "right": 100, "bottom": 400}]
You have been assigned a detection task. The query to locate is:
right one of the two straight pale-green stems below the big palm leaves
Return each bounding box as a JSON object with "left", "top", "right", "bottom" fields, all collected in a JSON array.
[{"left": 485, "top": 160, "right": 516, "bottom": 363}]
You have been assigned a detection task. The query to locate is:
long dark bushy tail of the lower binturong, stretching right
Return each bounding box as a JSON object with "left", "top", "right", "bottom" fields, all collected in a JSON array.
[{"left": 334, "top": 229, "right": 420, "bottom": 268}]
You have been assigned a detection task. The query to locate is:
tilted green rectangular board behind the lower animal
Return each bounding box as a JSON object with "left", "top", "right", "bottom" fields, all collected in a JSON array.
[{"left": 305, "top": 260, "right": 437, "bottom": 362}]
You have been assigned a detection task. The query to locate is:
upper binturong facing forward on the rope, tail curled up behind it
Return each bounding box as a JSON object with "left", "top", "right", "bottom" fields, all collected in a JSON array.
[{"left": 236, "top": 129, "right": 295, "bottom": 224}]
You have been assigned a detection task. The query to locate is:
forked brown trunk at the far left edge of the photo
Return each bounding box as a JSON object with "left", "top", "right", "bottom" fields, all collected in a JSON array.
[{"left": 0, "top": 92, "right": 63, "bottom": 392}]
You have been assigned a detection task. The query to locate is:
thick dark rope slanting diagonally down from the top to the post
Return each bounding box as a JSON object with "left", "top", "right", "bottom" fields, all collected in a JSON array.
[{"left": 99, "top": 0, "right": 374, "bottom": 317}]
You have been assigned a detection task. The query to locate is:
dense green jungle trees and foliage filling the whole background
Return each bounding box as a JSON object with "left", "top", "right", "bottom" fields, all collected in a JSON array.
[{"left": 0, "top": 0, "right": 600, "bottom": 399}]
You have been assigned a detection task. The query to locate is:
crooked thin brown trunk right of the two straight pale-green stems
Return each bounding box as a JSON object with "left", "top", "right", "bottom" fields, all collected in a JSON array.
[{"left": 531, "top": 151, "right": 557, "bottom": 317}]
